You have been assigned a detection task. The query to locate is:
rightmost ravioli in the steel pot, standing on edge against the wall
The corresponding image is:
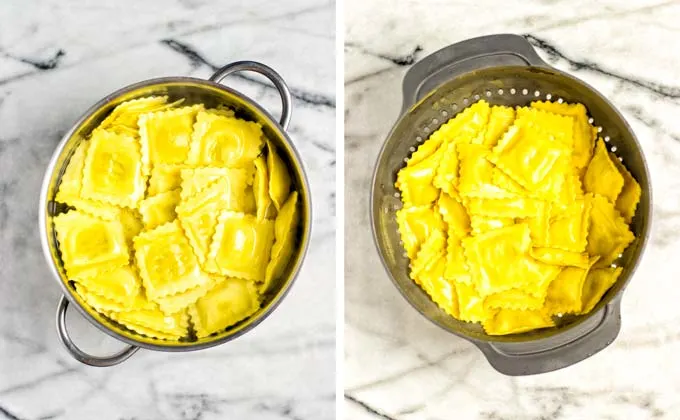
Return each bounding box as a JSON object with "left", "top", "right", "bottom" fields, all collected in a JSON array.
[{"left": 262, "top": 191, "right": 300, "bottom": 291}]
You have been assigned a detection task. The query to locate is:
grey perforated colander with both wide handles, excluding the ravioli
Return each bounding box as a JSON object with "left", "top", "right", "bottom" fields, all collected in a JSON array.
[{"left": 370, "top": 34, "right": 652, "bottom": 375}]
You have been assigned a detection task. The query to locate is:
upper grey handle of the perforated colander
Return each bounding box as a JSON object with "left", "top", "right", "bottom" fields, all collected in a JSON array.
[{"left": 401, "top": 34, "right": 549, "bottom": 114}]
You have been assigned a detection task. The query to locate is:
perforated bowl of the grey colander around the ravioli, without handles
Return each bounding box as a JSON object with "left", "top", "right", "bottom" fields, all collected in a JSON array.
[{"left": 371, "top": 66, "right": 651, "bottom": 342}]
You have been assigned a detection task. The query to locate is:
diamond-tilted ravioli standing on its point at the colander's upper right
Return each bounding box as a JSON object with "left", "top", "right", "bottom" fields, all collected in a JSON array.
[{"left": 583, "top": 139, "right": 624, "bottom": 203}]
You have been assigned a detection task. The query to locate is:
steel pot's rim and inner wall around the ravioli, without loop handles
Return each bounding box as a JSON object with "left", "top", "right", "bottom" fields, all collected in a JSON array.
[{"left": 40, "top": 77, "right": 311, "bottom": 351}]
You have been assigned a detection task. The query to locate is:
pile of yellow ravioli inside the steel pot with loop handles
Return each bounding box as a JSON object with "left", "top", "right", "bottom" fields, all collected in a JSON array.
[{"left": 53, "top": 97, "right": 299, "bottom": 341}]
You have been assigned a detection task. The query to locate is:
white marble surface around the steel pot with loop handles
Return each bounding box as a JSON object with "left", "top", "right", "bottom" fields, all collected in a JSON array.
[{"left": 0, "top": 0, "right": 335, "bottom": 420}]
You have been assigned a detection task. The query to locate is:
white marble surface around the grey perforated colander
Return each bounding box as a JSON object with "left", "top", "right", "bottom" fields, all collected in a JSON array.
[{"left": 344, "top": 0, "right": 680, "bottom": 420}]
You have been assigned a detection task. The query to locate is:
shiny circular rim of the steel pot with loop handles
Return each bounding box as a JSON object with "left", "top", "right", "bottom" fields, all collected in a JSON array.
[{"left": 38, "top": 76, "right": 313, "bottom": 352}]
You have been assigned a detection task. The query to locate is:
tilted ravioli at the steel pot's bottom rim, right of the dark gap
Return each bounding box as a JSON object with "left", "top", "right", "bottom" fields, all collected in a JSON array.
[{"left": 189, "top": 278, "right": 260, "bottom": 338}]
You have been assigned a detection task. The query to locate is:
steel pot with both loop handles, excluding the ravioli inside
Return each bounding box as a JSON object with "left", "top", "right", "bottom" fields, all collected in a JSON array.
[{"left": 39, "top": 61, "right": 312, "bottom": 366}]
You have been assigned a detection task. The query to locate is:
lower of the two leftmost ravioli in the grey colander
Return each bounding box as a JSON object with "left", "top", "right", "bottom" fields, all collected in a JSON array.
[{"left": 397, "top": 206, "right": 446, "bottom": 258}]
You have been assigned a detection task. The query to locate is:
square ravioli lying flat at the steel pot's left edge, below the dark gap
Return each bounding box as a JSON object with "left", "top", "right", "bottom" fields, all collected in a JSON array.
[{"left": 54, "top": 210, "right": 129, "bottom": 279}]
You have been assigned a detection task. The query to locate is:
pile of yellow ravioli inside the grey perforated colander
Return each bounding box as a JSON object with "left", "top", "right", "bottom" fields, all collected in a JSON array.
[{"left": 396, "top": 101, "right": 641, "bottom": 335}]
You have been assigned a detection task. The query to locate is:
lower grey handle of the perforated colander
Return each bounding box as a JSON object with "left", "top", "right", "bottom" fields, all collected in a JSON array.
[{"left": 474, "top": 298, "right": 621, "bottom": 376}]
